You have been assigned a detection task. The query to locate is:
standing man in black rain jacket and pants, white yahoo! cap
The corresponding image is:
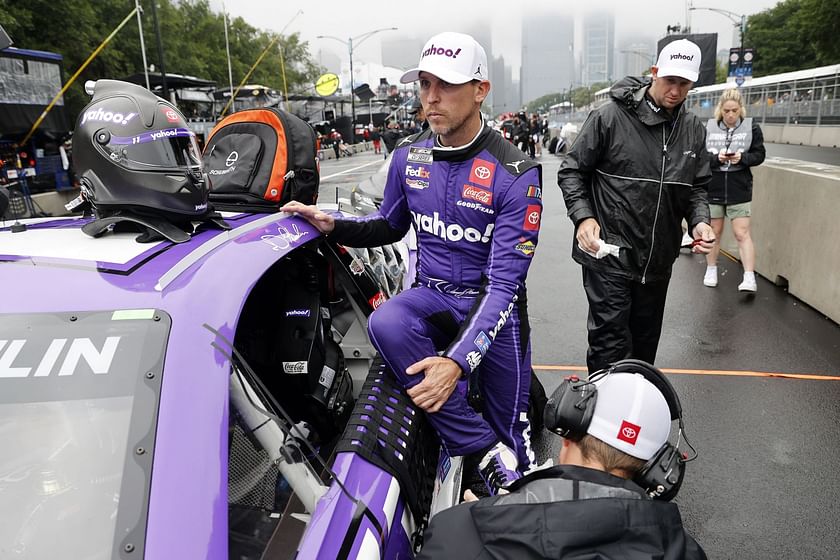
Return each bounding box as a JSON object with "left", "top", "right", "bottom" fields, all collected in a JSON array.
[{"left": 557, "top": 39, "right": 715, "bottom": 372}]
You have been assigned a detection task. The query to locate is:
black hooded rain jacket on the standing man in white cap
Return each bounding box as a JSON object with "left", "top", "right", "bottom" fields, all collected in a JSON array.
[{"left": 557, "top": 76, "right": 711, "bottom": 283}]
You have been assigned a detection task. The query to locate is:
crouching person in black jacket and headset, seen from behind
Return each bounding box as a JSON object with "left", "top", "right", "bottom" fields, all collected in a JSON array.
[{"left": 417, "top": 360, "right": 706, "bottom": 560}]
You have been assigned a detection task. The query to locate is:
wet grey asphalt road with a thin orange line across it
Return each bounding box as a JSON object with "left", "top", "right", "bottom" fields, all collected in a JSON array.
[{"left": 321, "top": 147, "right": 840, "bottom": 560}]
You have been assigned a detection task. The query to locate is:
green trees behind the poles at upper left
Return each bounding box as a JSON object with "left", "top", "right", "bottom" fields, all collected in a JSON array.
[{"left": 0, "top": 0, "right": 320, "bottom": 118}]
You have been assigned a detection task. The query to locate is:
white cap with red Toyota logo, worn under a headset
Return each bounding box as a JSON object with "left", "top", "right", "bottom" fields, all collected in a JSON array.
[{"left": 586, "top": 373, "right": 671, "bottom": 461}]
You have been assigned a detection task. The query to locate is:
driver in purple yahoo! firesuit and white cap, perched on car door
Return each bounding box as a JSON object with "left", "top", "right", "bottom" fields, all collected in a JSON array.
[{"left": 281, "top": 32, "right": 542, "bottom": 494}]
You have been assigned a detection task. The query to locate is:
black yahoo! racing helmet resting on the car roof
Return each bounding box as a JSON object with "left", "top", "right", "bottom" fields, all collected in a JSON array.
[{"left": 73, "top": 80, "right": 209, "bottom": 222}]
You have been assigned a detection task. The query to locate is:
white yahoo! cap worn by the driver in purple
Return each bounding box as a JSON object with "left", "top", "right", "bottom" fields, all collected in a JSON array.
[{"left": 400, "top": 31, "right": 487, "bottom": 84}]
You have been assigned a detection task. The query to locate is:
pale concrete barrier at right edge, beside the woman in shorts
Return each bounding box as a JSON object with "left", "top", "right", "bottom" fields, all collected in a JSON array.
[{"left": 721, "top": 158, "right": 840, "bottom": 323}]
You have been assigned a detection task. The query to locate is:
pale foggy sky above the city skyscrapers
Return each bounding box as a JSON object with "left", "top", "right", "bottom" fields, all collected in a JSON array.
[{"left": 210, "top": 0, "right": 776, "bottom": 71}]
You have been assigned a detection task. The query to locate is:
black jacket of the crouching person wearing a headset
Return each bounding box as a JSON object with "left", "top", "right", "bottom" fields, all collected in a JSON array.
[{"left": 417, "top": 465, "right": 706, "bottom": 560}]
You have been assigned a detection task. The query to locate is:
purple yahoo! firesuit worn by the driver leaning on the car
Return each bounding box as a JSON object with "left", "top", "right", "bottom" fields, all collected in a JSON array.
[{"left": 331, "top": 126, "right": 542, "bottom": 470}]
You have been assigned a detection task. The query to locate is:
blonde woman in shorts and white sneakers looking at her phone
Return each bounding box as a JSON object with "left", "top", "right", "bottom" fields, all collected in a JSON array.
[{"left": 703, "top": 89, "right": 765, "bottom": 292}]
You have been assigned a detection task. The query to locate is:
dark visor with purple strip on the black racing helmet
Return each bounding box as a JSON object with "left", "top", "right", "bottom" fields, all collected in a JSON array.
[{"left": 103, "top": 128, "right": 201, "bottom": 171}]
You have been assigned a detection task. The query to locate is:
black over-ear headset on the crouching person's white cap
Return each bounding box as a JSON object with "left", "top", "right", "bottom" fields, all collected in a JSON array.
[{"left": 544, "top": 359, "right": 697, "bottom": 501}]
